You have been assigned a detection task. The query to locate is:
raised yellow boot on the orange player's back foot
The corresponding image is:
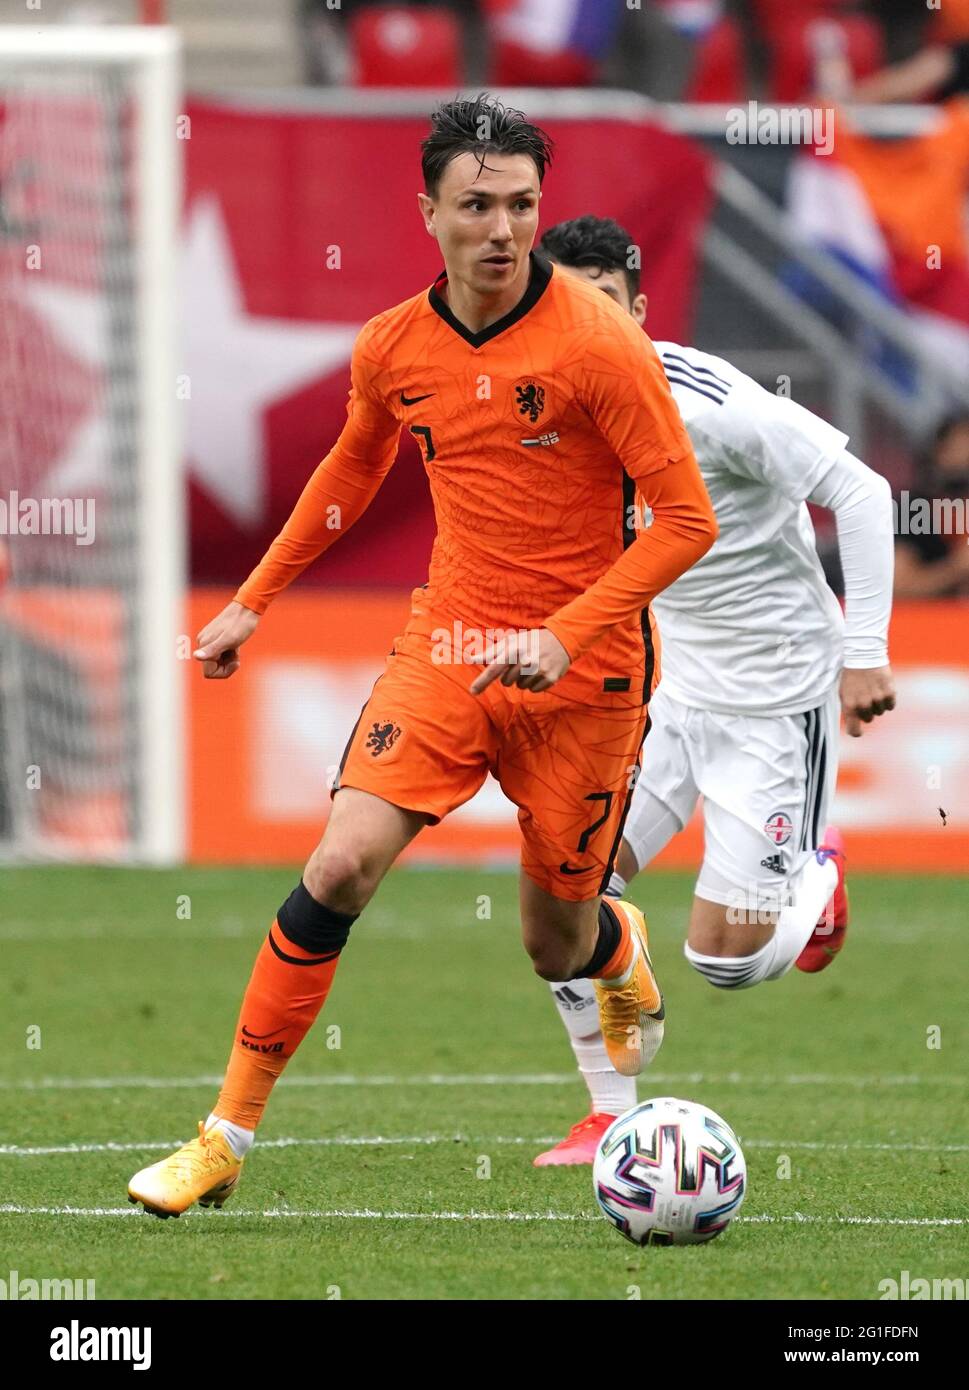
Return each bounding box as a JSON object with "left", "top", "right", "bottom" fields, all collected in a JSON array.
[{"left": 592, "top": 898, "right": 666, "bottom": 1076}]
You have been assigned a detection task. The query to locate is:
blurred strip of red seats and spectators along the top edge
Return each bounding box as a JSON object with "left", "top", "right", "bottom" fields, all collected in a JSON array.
[{"left": 300, "top": 0, "right": 969, "bottom": 103}]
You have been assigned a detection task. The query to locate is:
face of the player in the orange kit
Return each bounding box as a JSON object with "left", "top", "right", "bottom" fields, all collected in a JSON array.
[{"left": 418, "top": 153, "right": 541, "bottom": 295}]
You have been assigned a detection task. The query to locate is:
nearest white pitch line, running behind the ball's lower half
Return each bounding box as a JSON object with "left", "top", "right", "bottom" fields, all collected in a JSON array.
[{"left": 0, "top": 1202, "right": 969, "bottom": 1226}]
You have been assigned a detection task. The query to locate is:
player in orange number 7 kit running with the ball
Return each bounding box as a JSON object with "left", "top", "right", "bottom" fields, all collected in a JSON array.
[{"left": 128, "top": 95, "right": 716, "bottom": 1216}]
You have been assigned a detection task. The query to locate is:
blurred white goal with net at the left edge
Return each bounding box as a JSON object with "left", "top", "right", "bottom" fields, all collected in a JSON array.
[{"left": 0, "top": 25, "right": 186, "bottom": 865}]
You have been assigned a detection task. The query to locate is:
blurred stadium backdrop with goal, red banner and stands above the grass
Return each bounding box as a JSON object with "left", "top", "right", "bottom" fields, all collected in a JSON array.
[{"left": 0, "top": 0, "right": 969, "bottom": 873}]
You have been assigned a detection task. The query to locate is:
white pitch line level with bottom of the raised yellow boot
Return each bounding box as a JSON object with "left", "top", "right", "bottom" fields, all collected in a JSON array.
[{"left": 0, "top": 1072, "right": 969, "bottom": 1091}]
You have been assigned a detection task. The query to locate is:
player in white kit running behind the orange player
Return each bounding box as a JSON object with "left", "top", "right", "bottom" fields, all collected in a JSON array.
[{"left": 535, "top": 217, "right": 895, "bottom": 1166}]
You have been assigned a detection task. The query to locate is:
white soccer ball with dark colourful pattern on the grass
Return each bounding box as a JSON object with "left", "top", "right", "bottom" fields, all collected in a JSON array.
[{"left": 592, "top": 1095, "right": 747, "bottom": 1245}]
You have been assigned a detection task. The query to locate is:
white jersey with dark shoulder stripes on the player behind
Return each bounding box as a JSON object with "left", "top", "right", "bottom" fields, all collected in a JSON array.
[{"left": 652, "top": 342, "right": 848, "bottom": 714}]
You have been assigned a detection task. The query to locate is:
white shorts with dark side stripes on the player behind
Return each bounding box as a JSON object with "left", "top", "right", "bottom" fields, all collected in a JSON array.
[{"left": 623, "top": 684, "right": 840, "bottom": 909}]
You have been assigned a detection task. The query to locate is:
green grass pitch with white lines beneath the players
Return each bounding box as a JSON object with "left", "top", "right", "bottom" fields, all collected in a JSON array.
[{"left": 0, "top": 869, "right": 969, "bottom": 1300}]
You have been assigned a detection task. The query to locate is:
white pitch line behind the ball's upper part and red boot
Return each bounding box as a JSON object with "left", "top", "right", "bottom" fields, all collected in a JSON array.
[{"left": 0, "top": 1134, "right": 969, "bottom": 1158}]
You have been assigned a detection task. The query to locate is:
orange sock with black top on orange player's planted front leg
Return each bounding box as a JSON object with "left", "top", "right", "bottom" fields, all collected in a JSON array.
[{"left": 213, "top": 883, "right": 356, "bottom": 1130}]
